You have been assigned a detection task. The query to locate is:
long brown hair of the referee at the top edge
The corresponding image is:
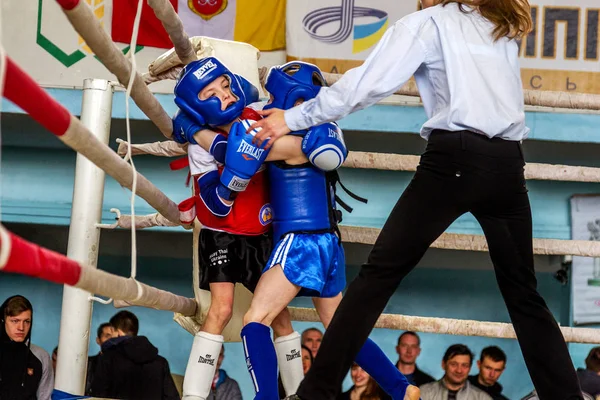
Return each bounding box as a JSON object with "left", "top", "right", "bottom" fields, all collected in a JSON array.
[{"left": 437, "top": 0, "right": 533, "bottom": 40}]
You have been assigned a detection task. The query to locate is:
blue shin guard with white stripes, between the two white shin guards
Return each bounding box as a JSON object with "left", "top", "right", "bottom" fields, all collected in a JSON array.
[{"left": 242, "top": 322, "right": 279, "bottom": 400}]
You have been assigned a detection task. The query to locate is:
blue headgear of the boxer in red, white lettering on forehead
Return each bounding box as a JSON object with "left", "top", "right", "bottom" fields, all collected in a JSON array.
[{"left": 175, "top": 57, "right": 258, "bottom": 127}]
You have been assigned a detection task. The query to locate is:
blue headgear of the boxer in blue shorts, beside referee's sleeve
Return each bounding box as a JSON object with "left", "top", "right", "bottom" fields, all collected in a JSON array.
[{"left": 264, "top": 61, "right": 327, "bottom": 110}]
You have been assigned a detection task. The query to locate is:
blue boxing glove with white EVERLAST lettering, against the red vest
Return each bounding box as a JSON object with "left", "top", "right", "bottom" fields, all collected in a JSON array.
[{"left": 221, "top": 120, "right": 269, "bottom": 192}]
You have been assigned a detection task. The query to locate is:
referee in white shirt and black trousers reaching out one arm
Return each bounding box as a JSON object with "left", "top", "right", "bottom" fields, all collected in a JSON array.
[{"left": 250, "top": 0, "right": 582, "bottom": 400}]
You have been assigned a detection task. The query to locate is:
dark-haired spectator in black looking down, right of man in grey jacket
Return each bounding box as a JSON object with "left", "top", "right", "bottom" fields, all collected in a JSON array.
[{"left": 469, "top": 346, "right": 508, "bottom": 400}]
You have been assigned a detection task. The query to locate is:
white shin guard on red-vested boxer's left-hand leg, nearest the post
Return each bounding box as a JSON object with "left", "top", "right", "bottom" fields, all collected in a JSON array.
[{"left": 183, "top": 331, "right": 223, "bottom": 400}]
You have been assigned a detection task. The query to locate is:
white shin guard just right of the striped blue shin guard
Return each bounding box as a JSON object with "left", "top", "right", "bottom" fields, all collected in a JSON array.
[{"left": 275, "top": 332, "right": 304, "bottom": 396}]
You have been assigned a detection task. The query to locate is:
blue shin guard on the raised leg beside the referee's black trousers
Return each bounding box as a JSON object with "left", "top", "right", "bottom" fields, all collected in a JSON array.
[{"left": 356, "top": 339, "right": 410, "bottom": 400}]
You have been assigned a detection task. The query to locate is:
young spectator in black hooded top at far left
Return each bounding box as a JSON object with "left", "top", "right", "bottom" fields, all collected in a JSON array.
[{"left": 0, "top": 296, "right": 54, "bottom": 400}]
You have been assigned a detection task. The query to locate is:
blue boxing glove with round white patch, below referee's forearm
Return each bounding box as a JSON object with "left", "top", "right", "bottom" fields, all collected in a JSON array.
[{"left": 302, "top": 122, "right": 348, "bottom": 171}]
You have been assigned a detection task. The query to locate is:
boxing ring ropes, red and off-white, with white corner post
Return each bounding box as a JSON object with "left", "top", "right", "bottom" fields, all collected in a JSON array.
[{"left": 0, "top": 0, "right": 600, "bottom": 394}]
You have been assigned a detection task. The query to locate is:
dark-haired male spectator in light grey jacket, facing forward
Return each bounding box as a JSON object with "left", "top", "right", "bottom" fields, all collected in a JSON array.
[{"left": 420, "top": 344, "right": 491, "bottom": 400}]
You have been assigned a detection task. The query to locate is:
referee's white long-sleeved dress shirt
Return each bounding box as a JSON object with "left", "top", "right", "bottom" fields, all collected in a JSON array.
[{"left": 285, "top": 3, "right": 529, "bottom": 140}]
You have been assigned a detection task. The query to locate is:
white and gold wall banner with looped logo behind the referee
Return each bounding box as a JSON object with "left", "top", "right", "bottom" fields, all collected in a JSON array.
[{"left": 286, "top": 0, "right": 600, "bottom": 94}]
